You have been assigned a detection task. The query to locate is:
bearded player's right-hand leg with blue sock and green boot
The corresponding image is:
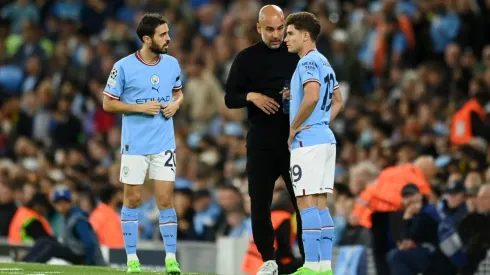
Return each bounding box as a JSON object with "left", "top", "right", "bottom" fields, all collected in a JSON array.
[{"left": 154, "top": 180, "right": 181, "bottom": 275}]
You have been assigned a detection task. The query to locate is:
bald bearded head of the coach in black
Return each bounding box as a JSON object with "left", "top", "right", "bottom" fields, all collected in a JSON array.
[{"left": 257, "top": 5, "right": 285, "bottom": 49}]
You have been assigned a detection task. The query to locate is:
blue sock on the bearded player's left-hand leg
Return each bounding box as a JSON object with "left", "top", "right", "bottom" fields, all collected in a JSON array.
[{"left": 121, "top": 206, "right": 140, "bottom": 261}]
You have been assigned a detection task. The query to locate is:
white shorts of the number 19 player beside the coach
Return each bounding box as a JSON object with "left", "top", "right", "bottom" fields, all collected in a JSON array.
[{"left": 290, "top": 143, "right": 337, "bottom": 197}]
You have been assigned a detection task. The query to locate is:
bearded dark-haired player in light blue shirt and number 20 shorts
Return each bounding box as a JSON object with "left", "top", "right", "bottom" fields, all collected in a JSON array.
[{"left": 103, "top": 14, "right": 184, "bottom": 275}]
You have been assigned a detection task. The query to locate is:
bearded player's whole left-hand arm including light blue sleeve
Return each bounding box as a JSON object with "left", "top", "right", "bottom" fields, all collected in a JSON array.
[{"left": 102, "top": 63, "right": 160, "bottom": 115}]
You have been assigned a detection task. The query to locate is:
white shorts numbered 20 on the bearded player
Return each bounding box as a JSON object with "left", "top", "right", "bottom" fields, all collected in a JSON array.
[{"left": 120, "top": 150, "right": 176, "bottom": 185}]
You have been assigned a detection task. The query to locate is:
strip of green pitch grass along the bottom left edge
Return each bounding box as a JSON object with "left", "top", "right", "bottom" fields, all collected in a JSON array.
[{"left": 0, "top": 263, "right": 218, "bottom": 275}]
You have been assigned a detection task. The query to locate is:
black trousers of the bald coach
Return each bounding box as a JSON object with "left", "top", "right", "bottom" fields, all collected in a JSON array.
[{"left": 247, "top": 147, "right": 304, "bottom": 262}]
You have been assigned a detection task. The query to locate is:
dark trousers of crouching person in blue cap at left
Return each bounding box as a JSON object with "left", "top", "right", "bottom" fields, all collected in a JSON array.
[{"left": 22, "top": 238, "right": 85, "bottom": 264}]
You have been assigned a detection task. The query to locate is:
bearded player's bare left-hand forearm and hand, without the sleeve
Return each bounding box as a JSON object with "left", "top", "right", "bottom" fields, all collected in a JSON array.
[{"left": 102, "top": 94, "right": 161, "bottom": 115}]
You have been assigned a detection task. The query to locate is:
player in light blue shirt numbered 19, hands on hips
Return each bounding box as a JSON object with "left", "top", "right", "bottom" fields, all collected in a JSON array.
[{"left": 285, "top": 12, "right": 343, "bottom": 275}]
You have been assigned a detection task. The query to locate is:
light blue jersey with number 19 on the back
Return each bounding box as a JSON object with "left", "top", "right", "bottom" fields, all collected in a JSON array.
[{"left": 289, "top": 49, "right": 339, "bottom": 150}]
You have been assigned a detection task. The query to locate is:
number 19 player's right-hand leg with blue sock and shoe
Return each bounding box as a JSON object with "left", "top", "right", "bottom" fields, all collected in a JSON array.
[{"left": 317, "top": 193, "right": 334, "bottom": 275}]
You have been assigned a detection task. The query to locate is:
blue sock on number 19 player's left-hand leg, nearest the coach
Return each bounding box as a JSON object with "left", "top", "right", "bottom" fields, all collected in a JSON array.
[{"left": 301, "top": 207, "right": 321, "bottom": 271}]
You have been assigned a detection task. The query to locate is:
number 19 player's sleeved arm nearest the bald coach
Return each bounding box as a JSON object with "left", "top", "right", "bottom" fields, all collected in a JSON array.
[{"left": 291, "top": 60, "right": 320, "bottom": 131}]
